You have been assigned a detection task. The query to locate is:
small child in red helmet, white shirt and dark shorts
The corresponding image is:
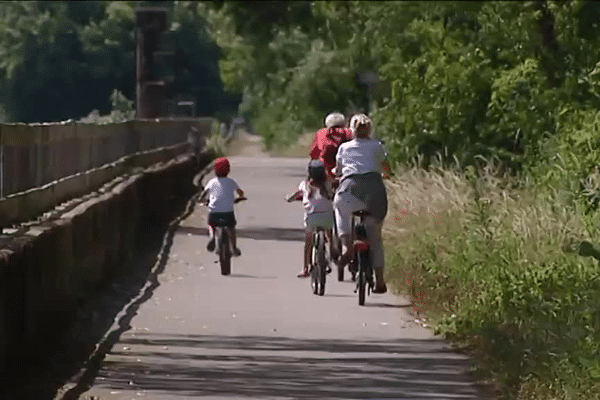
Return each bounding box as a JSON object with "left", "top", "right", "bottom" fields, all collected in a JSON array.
[{"left": 200, "top": 157, "right": 244, "bottom": 257}]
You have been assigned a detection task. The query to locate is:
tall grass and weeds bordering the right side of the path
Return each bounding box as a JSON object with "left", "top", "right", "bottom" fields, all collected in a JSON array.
[{"left": 384, "top": 155, "right": 600, "bottom": 399}]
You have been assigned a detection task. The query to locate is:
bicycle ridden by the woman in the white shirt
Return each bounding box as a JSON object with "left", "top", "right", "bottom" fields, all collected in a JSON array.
[{"left": 349, "top": 210, "right": 375, "bottom": 306}]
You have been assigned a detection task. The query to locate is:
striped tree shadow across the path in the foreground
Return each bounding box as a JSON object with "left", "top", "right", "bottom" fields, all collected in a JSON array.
[{"left": 86, "top": 334, "right": 489, "bottom": 400}]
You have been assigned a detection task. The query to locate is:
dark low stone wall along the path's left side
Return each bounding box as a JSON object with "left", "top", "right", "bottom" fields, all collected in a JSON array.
[{"left": 0, "top": 149, "right": 212, "bottom": 398}]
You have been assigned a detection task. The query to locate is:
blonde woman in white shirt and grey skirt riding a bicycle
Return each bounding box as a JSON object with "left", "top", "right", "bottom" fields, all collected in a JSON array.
[{"left": 333, "top": 114, "right": 391, "bottom": 293}]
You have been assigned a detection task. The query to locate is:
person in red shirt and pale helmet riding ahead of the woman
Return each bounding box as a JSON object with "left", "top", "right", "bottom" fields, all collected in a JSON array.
[{"left": 310, "top": 112, "right": 354, "bottom": 178}]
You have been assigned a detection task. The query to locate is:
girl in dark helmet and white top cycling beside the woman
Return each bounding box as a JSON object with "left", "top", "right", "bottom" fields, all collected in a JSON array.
[{"left": 285, "top": 160, "right": 334, "bottom": 278}]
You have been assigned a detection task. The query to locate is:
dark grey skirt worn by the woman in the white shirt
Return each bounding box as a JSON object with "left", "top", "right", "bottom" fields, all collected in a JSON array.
[{"left": 337, "top": 172, "right": 388, "bottom": 221}]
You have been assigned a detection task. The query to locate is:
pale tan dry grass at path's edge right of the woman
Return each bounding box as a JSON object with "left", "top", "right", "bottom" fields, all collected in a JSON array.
[{"left": 383, "top": 163, "right": 472, "bottom": 314}]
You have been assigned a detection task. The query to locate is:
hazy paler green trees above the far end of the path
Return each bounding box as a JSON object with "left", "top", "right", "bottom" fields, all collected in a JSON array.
[{"left": 199, "top": 2, "right": 365, "bottom": 147}]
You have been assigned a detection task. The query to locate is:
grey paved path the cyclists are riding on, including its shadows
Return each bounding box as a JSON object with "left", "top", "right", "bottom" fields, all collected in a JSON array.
[{"left": 64, "top": 157, "right": 483, "bottom": 400}]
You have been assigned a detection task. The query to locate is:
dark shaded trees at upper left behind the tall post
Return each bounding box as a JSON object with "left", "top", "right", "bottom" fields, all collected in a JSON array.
[{"left": 0, "top": 1, "right": 239, "bottom": 122}]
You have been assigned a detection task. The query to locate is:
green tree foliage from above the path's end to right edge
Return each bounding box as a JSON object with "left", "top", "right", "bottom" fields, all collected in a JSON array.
[{"left": 199, "top": 1, "right": 600, "bottom": 180}]
